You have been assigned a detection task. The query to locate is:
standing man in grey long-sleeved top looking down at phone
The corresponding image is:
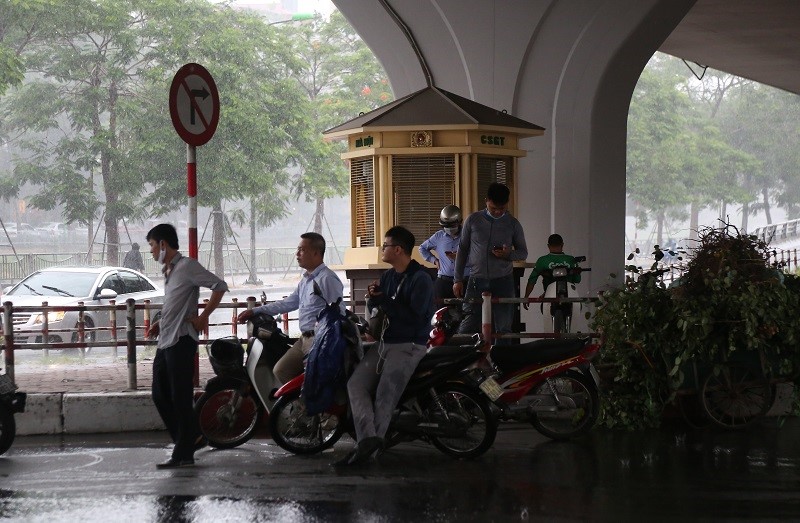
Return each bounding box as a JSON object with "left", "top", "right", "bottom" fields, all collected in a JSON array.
[{"left": 453, "top": 182, "right": 528, "bottom": 342}]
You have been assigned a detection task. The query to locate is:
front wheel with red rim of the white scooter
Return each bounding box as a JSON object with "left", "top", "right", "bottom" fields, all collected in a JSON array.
[{"left": 194, "top": 380, "right": 264, "bottom": 449}]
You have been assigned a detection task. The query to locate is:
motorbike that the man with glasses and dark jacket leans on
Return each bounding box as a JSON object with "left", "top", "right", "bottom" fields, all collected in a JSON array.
[{"left": 269, "top": 314, "right": 497, "bottom": 458}]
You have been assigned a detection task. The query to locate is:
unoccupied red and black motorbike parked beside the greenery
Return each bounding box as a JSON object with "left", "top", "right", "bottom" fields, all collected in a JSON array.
[{"left": 430, "top": 303, "right": 600, "bottom": 440}]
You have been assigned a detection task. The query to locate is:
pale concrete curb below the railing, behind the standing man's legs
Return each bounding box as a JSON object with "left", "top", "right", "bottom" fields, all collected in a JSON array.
[{"left": 8, "top": 357, "right": 219, "bottom": 436}]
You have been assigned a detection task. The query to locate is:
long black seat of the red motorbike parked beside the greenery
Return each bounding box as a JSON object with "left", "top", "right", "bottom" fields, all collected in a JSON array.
[{"left": 489, "top": 337, "right": 590, "bottom": 372}]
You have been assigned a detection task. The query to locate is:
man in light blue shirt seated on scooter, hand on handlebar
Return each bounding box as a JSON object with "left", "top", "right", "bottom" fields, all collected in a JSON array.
[{"left": 237, "top": 232, "right": 345, "bottom": 384}]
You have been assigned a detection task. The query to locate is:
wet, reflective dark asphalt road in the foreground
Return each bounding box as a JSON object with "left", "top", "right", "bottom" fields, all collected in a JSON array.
[{"left": 0, "top": 419, "right": 800, "bottom": 523}]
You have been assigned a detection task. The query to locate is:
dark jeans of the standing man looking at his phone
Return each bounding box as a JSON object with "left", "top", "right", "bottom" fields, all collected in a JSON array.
[{"left": 458, "top": 274, "right": 514, "bottom": 344}]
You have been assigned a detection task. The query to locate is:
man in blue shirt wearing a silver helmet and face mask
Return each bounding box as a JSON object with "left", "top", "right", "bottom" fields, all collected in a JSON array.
[{"left": 419, "top": 205, "right": 469, "bottom": 305}]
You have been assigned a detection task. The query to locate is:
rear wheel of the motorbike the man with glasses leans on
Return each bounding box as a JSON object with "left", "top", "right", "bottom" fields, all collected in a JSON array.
[{"left": 425, "top": 384, "right": 497, "bottom": 459}]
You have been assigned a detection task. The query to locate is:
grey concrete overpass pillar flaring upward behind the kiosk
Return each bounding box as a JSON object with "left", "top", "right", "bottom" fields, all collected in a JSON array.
[{"left": 333, "top": 0, "right": 695, "bottom": 328}]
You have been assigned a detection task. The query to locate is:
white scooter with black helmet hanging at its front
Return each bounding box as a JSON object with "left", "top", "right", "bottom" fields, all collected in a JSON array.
[{"left": 194, "top": 314, "right": 292, "bottom": 449}]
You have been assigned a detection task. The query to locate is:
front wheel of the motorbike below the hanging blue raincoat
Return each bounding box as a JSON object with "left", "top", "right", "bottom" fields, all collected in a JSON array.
[{"left": 269, "top": 390, "right": 345, "bottom": 454}]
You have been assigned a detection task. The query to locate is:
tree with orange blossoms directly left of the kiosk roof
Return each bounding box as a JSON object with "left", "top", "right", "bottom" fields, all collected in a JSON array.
[{"left": 281, "top": 11, "right": 393, "bottom": 234}]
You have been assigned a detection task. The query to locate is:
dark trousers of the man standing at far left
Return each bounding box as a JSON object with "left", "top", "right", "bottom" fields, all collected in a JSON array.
[{"left": 152, "top": 336, "right": 200, "bottom": 460}]
